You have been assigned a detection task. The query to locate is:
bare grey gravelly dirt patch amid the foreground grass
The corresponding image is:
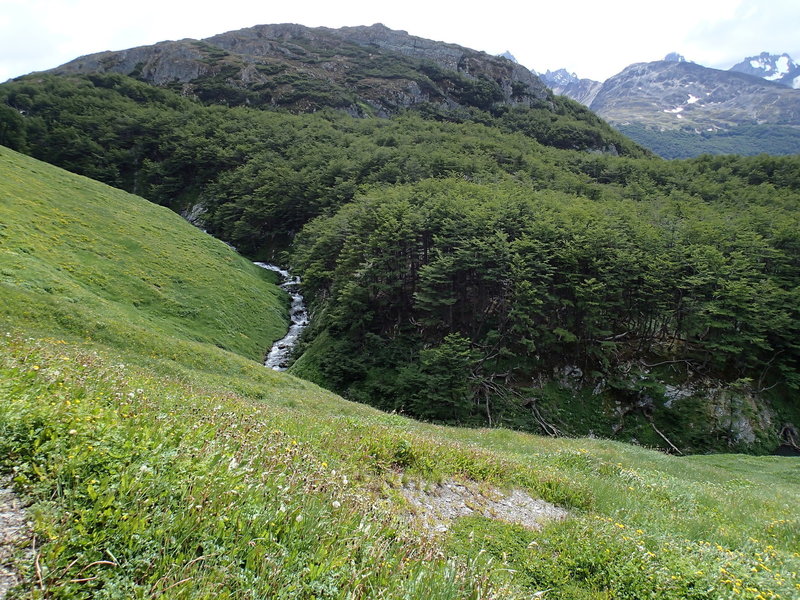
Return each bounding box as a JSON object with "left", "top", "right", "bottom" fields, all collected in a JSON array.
[{"left": 400, "top": 480, "right": 569, "bottom": 532}]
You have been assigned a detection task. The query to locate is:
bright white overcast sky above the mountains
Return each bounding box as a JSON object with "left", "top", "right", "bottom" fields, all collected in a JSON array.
[{"left": 0, "top": 0, "right": 800, "bottom": 82}]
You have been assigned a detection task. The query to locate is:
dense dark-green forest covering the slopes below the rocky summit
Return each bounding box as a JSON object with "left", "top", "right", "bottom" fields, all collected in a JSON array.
[{"left": 0, "top": 75, "right": 800, "bottom": 451}]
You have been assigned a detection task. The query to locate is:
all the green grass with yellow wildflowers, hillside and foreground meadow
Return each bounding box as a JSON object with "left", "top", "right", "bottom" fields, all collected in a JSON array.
[{"left": 0, "top": 149, "right": 800, "bottom": 600}]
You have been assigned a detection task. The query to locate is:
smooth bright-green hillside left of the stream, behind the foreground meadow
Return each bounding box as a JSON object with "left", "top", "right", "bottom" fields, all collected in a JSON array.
[{"left": 0, "top": 147, "right": 287, "bottom": 365}]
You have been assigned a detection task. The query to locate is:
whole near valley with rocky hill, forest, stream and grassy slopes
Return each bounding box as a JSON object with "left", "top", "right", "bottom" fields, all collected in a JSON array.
[{"left": 0, "top": 25, "right": 800, "bottom": 600}]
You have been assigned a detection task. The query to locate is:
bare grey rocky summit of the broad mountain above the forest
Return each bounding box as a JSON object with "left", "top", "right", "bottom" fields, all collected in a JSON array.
[{"left": 53, "top": 24, "right": 551, "bottom": 116}]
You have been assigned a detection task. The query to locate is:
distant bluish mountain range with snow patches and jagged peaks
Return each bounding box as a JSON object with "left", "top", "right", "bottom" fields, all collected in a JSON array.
[{"left": 540, "top": 52, "right": 800, "bottom": 158}]
